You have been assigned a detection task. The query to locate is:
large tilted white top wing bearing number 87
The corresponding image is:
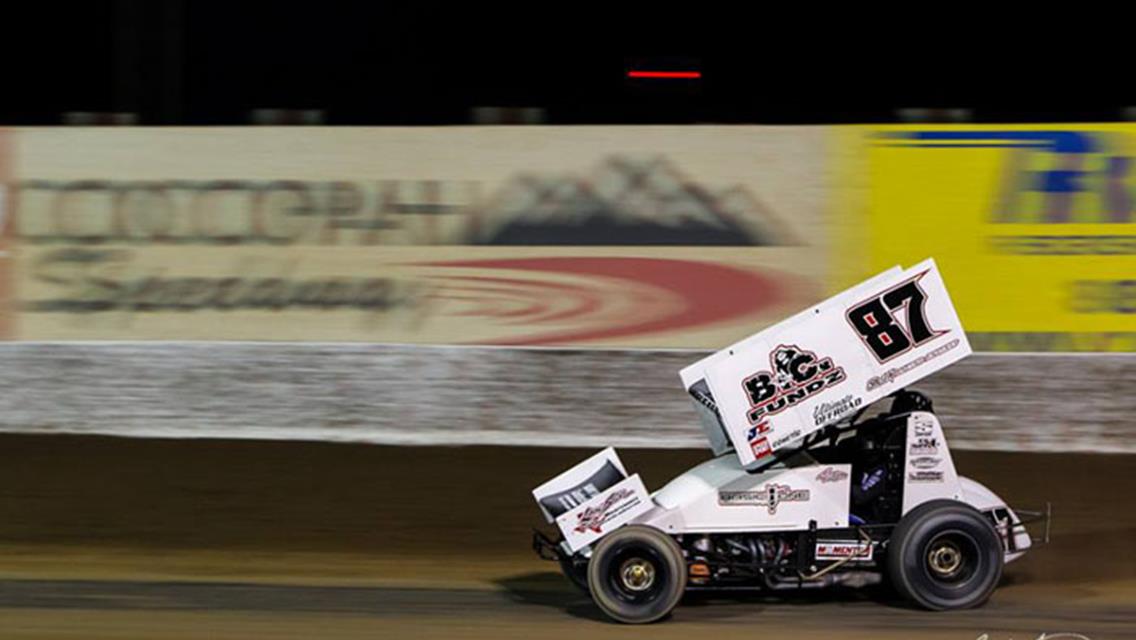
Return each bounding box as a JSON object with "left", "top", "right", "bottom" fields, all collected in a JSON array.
[{"left": 682, "top": 259, "right": 970, "bottom": 466}]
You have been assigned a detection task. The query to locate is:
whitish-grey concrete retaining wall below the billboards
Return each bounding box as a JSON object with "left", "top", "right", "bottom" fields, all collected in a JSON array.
[{"left": 0, "top": 342, "right": 1136, "bottom": 452}]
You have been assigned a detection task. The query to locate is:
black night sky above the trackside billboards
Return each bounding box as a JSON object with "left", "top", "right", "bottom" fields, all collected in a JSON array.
[{"left": 0, "top": 0, "right": 1136, "bottom": 125}]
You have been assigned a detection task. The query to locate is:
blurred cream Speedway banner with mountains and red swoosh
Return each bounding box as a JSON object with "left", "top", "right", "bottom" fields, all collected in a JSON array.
[{"left": 4, "top": 126, "right": 827, "bottom": 347}]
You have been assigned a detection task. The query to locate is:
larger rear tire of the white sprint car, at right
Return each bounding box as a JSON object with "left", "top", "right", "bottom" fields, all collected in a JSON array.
[{"left": 887, "top": 500, "right": 1003, "bottom": 610}]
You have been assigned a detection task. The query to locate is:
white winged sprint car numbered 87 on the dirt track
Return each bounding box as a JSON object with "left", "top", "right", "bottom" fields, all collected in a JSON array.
[{"left": 533, "top": 260, "right": 1049, "bottom": 623}]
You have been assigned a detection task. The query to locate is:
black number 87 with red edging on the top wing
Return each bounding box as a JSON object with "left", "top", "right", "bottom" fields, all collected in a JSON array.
[{"left": 845, "top": 272, "right": 946, "bottom": 363}]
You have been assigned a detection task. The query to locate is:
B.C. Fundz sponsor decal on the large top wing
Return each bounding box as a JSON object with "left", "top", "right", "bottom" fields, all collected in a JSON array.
[{"left": 742, "top": 344, "right": 847, "bottom": 425}]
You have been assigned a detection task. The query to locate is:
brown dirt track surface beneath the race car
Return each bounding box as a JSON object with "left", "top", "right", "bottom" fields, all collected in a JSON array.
[{"left": 0, "top": 435, "right": 1136, "bottom": 640}]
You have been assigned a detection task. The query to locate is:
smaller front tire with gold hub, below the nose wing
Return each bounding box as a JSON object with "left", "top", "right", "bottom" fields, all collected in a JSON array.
[{"left": 587, "top": 525, "right": 686, "bottom": 624}]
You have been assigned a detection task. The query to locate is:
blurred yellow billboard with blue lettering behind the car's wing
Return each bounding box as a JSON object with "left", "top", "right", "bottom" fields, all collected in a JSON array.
[{"left": 833, "top": 124, "right": 1136, "bottom": 351}]
